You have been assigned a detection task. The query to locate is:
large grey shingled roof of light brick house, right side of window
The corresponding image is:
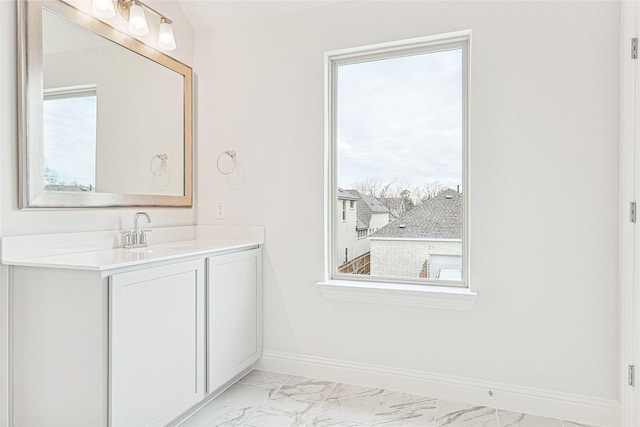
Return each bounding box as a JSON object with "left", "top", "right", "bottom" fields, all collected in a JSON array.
[{"left": 370, "top": 189, "right": 462, "bottom": 239}]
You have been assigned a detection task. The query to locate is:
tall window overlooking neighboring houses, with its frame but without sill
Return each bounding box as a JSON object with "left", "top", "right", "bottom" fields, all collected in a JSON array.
[{"left": 325, "top": 32, "right": 470, "bottom": 287}]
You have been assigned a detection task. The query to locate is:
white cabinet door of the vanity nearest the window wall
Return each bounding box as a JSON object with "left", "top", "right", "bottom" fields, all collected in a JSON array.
[{"left": 207, "top": 249, "right": 262, "bottom": 392}]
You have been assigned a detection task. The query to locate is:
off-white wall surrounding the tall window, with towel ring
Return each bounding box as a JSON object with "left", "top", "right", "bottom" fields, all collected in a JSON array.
[{"left": 196, "top": 1, "right": 619, "bottom": 418}]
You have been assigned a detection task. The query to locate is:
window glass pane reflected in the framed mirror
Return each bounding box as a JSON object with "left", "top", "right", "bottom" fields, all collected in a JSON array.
[{"left": 43, "top": 94, "right": 97, "bottom": 191}]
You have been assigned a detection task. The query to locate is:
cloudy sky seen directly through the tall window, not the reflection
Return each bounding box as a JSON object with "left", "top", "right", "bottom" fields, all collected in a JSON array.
[{"left": 337, "top": 49, "right": 462, "bottom": 192}]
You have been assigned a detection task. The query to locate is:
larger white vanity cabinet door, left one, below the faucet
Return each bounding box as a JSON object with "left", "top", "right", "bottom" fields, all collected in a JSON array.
[{"left": 110, "top": 261, "right": 205, "bottom": 427}]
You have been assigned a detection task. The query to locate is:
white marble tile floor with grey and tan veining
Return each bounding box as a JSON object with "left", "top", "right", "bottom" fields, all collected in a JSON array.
[{"left": 180, "top": 370, "right": 588, "bottom": 427}]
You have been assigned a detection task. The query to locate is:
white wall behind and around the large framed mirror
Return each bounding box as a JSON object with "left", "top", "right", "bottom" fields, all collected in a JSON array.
[{"left": 0, "top": 0, "right": 195, "bottom": 238}]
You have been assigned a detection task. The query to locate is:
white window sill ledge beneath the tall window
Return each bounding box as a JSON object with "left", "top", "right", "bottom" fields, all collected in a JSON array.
[{"left": 317, "top": 280, "right": 478, "bottom": 311}]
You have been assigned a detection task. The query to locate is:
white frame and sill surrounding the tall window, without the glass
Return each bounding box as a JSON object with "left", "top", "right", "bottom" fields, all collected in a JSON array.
[{"left": 318, "top": 30, "right": 477, "bottom": 311}]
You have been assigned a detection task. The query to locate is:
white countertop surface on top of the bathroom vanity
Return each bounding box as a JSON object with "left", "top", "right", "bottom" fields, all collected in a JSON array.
[{"left": 2, "top": 239, "right": 264, "bottom": 271}]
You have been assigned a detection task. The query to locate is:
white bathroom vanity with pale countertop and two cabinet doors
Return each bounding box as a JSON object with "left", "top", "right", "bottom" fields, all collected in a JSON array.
[{"left": 3, "top": 227, "right": 264, "bottom": 427}]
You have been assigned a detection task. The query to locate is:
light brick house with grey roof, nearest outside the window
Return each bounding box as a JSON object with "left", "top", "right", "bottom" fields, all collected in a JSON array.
[{"left": 369, "top": 189, "right": 462, "bottom": 280}]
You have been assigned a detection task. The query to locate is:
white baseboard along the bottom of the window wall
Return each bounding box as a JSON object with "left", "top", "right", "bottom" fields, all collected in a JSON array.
[{"left": 256, "top": 350, "right": 620, "bottom": 427}]
